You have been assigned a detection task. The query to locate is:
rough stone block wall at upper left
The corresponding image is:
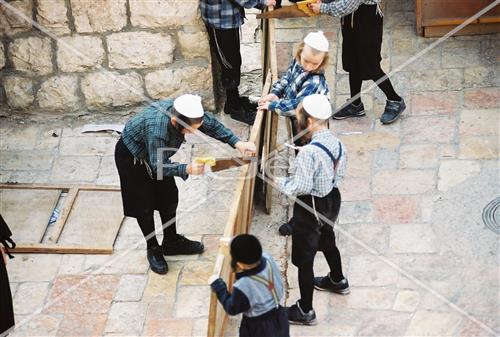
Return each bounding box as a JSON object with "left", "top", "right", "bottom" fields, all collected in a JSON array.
[{"left": 0, "top": 0, "right": 214, "bottom": 113}]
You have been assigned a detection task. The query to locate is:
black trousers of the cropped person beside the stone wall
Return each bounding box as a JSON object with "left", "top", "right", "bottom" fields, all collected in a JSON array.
[{"left": 206, "top": 25, "right": 241, "bottom": 90}]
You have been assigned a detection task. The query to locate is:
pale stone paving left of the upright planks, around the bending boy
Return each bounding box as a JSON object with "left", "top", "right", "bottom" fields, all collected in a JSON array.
[{"left": 0, "top": 111, "right": 249, "bottom": 336}]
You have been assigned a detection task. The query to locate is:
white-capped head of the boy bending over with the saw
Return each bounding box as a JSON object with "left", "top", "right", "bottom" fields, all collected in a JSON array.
[{"left": 171, "top": 94, "right": 204, "bottom": 134}]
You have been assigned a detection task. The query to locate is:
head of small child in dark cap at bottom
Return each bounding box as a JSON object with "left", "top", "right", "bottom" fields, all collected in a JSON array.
[{"left": 231, "top": 234, "right": 262, "bottom": 270}]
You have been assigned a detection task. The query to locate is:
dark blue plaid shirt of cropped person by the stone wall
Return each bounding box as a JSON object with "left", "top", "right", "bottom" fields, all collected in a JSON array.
[{"left": 200, "top": 0, "right": 266, "bottom": 29}]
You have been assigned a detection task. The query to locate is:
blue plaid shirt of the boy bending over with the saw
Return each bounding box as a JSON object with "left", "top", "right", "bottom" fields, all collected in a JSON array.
[{"left": 122, "top": 99, "right": 240, "bottom": 179}]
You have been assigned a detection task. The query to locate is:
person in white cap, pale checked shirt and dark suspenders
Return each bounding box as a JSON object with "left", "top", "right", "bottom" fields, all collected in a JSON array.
[{"left": 276, "top": 95, "right": 349, "bottom": 325}]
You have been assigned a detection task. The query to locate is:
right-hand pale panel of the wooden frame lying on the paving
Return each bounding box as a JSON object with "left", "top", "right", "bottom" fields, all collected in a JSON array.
[{"left": 57, "top": 191, "right": 123, "bottom": 248}]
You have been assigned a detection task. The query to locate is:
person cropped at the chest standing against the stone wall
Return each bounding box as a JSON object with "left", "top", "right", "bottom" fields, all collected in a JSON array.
[{"left": 200, "top": 0, "right": 276, "bottom": 125}]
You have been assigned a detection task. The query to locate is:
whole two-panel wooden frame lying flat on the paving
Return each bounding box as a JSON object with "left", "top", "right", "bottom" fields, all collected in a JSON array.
[{"left": 0, "top": 184, "right": 123, "bottom": 254}]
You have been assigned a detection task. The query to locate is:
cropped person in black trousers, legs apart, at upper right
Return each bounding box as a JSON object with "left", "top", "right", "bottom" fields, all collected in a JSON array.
[{"left": 309, "top": 0, "right": 406, "bottom": 124}]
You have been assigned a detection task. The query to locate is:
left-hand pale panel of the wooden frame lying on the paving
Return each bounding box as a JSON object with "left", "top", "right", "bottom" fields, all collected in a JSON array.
[{"left": 0, "top": 188, "right": 61, "bottom": 243}]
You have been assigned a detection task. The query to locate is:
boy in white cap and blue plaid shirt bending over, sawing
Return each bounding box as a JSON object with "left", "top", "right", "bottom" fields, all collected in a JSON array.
[{"left": 115, "top": 95, "right": 255, "bottom": 274}]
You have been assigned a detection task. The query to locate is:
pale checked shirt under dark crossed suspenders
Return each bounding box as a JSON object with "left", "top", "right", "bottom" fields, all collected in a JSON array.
[{"left": 277, "top": 130, "right": 347, "bottom": 198}]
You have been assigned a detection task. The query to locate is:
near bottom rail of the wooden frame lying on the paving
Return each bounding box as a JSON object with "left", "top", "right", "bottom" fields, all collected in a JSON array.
[{"left": 10, "top": 242, "right": 113, "bottom": 254}]
